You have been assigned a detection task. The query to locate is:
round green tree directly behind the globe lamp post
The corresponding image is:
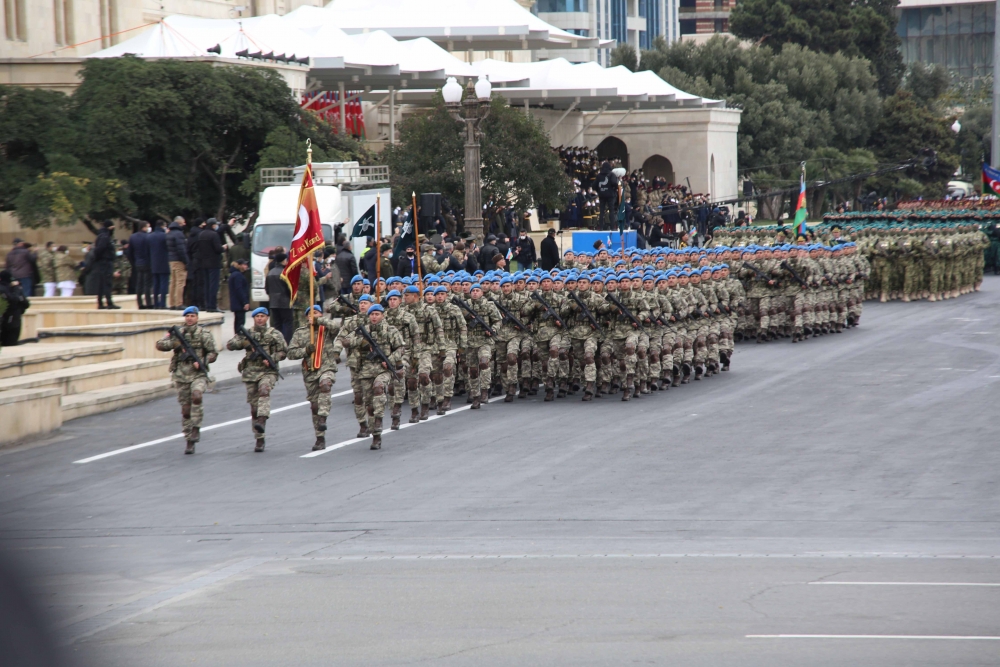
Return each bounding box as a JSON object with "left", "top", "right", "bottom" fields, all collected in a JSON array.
[{"left": 384, "top": 96, "right": 570, "bottom": 237}]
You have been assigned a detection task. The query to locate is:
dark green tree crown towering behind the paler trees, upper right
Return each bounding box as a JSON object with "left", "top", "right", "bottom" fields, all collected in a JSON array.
[{"left": 729, "top": 0, "right": 903, "bottom": 95}]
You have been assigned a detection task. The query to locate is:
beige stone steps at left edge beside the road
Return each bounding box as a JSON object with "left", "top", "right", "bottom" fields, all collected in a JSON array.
[{"left": 0, "top": 342, "right": 171, "bottom": 443}]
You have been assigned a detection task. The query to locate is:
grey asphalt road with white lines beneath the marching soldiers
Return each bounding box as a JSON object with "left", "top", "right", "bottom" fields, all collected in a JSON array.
[{"left": 0, "top": 276, "right": 1000, "bottom": 666}]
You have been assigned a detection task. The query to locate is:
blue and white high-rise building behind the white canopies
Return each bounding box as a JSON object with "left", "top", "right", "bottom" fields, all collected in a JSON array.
[{"left": 532, "top": 0, "right": 680, "bottom": 65}]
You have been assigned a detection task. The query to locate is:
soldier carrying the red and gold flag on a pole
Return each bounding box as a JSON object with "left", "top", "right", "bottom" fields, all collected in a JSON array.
[{"left": 288, "top": 306, "right": 344, "bottom": 451}]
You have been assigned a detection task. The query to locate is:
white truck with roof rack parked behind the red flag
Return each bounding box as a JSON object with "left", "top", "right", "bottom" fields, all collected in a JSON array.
[{"left": 250, "top": 162, "right": 392, "bottom": 301}]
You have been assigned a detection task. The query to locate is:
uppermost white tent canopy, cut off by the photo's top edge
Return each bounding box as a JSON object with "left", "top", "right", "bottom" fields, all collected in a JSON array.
[{"left": 324, "top": 0, "right": 614, "bottom": 51}]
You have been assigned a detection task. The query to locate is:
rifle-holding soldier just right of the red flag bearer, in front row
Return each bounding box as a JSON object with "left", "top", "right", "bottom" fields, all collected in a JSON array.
[{"left": 348, "top": 303, "right": 404, "bottom": 449}]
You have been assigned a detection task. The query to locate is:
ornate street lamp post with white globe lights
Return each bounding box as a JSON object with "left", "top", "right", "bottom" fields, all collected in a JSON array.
[{"left": 441, "top": 77, "right": 492, "bottom": 243}]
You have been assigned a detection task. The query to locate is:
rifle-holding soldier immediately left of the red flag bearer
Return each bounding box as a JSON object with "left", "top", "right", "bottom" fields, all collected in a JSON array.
[{"left": 226, "top": 308, "right": 288, "bottom": 452}]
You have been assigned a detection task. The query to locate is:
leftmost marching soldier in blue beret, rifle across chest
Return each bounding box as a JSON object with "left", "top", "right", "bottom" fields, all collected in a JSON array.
[{"left": 156, "top": 306, "right": 218, "bottom": 454}]
